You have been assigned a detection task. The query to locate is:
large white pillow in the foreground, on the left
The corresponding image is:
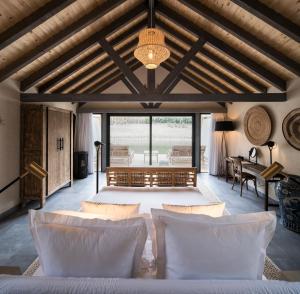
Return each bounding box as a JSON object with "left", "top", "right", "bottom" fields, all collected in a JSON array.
[{"left": 29, "top": 210, "right": 147, "bottom": 278}]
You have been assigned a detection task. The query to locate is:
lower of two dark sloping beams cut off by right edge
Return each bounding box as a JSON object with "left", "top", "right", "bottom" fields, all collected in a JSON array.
[{"left": 180, "top": 0, "right": 300, "bottom": 76}]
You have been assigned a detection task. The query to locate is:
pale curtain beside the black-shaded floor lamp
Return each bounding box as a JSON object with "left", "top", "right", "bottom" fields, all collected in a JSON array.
[{"left": 209, "top": 113, "right": 225, "bottom": 176}]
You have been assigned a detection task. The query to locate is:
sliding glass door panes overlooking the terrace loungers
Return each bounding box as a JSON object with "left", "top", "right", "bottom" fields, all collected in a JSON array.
[{"left": 108, "top": 115, "right": 193, "bottom": 167}]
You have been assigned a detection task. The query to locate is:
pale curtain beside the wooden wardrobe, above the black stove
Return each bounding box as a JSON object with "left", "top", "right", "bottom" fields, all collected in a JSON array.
[{"left": 75, "top": 113, "right": 94, "bottom": 174}]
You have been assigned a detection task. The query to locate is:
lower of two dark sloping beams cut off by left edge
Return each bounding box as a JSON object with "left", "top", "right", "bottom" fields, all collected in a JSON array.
[{"left": 0, "top": 0, "right": 125, "bottom": 82}]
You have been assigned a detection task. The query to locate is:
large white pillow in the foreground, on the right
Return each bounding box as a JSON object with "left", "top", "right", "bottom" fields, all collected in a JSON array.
[{"left": 151, "top": 209, "right": 276, "bottom": 280}]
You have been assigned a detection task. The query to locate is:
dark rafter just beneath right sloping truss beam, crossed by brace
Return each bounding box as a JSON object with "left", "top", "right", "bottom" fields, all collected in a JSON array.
[{"left": 156, "top": 20, "right": 267, "bottom": 93}]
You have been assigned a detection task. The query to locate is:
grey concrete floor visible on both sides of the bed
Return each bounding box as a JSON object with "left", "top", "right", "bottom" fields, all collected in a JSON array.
[{"left": 0, "top": 174, "right": 300, "bottom": 271}]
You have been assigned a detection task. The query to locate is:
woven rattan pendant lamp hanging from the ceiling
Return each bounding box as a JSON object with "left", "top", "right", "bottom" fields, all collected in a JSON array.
[{"left": 134, "top": 28, "right": 170, "bottom": 69}]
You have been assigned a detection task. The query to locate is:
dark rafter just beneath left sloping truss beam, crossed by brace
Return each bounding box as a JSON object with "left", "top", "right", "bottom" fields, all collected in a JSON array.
[{"left": 38, "top": 20, "right": 146, "bottom": 93}]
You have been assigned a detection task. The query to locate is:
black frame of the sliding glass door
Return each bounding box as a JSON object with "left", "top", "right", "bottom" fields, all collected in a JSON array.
[{"left": 106, "top": 113, "right": 196, "bottom": 167}]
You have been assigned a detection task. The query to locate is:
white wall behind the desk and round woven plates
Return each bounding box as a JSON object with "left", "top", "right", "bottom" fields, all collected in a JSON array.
[{"left": 227, "top": 78, "right": 300, "bottom": 175}]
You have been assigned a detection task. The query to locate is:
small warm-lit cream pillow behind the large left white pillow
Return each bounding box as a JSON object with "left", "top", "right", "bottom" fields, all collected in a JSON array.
[{"left": 80, "top": 201, "right": 140, "bottom": 219}]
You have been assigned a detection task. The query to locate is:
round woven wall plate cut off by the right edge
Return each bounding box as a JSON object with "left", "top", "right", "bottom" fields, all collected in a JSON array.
[{"left": 282, "top": 108, "right": 300, "bottom": 150}]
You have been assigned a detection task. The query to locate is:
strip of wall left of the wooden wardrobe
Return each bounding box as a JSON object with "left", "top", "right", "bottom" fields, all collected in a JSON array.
[{"left": 0, "top": 80, "right": 20, "bottom": 214}]
